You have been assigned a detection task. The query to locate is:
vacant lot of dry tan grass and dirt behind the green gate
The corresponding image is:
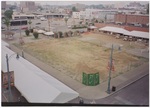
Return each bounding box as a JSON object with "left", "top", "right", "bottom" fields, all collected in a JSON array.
[{"left": 17, "top": 34, "right": 148, "bottom": 82}]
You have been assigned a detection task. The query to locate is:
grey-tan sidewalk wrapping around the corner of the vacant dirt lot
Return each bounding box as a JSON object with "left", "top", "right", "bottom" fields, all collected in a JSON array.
[{"left": 10, "top": 45, "right": 149, "bottom": 100}]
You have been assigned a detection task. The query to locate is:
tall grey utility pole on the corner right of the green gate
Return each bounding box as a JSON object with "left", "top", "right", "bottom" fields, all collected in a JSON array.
[{"left": 107, "top": 44, "right": 113, "bottom": 94}]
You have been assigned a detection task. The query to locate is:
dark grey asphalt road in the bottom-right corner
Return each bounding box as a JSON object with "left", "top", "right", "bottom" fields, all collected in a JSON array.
[{"left": 96, "top": 74, "right": 149, "bottom": 105}]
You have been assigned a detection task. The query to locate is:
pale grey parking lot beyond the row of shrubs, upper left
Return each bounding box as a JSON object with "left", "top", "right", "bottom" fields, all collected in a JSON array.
[{"left": 2, "top": 18, "right": 79, "bottom": 33}]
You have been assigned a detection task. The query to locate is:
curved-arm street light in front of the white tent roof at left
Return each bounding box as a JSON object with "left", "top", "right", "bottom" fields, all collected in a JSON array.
[{"left": 6, "top": 53, "right": 19, "bottom": 102}]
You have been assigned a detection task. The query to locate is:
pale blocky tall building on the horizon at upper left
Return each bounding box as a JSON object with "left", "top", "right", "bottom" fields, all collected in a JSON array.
[{"left": 20, "top": 1, "right": 36, "bottom": 12}]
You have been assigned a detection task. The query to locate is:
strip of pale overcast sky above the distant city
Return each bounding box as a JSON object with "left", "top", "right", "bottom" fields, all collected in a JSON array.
[{"left": 7, "top": 0, "right": 149, "bottom": 7}]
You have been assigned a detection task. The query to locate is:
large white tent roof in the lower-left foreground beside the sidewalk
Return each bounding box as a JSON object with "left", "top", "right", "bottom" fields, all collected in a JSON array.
[{"left": 2, "top": 41, "right": 79, "bottom": 103}]
